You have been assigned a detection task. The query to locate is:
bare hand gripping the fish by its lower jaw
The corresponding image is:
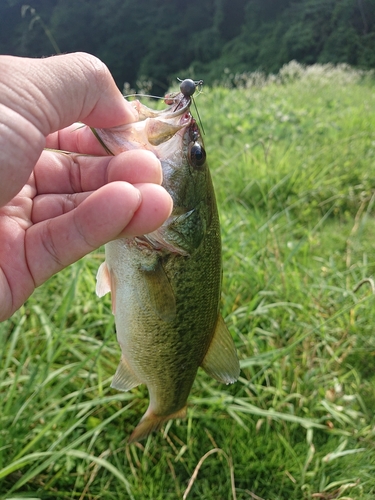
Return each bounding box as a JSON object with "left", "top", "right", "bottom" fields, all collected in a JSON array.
[{"left": 0, "top": 53, "right": 172, "bottom": 321}]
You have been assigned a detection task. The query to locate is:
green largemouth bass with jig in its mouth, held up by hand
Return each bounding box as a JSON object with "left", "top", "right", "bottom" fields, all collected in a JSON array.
[{"left": 94, "top": 79, "right": 240, "bottom": 443}]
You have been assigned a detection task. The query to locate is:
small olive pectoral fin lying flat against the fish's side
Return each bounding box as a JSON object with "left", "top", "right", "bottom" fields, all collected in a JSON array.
[{"left": 142, "top": 260, "right": 176, "bottom": 322}]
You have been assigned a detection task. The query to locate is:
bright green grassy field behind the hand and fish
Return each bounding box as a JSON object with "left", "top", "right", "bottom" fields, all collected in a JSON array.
[{"left": 0, "top": 64, "right": 375, "bottom": 500}]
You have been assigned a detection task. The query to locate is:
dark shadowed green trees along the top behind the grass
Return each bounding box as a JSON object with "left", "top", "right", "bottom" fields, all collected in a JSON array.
[{"left": 0, "top": 0, "right": 375, "bottom": 92}]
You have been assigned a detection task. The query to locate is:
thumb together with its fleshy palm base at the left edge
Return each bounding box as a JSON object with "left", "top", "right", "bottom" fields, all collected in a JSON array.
[{"left": 0, "top": 53, "right": 136, "bottom": 207}]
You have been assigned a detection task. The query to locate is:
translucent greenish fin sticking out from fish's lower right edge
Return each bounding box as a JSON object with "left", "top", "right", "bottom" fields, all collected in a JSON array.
[{"left": 201, "top": 315, "right": 240, "bottom": 384}]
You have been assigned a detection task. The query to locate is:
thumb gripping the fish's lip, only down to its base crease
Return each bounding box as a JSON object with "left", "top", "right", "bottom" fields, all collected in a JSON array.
[{"left": 0, "top": 52, "right": 135, "bottom": 136}]
